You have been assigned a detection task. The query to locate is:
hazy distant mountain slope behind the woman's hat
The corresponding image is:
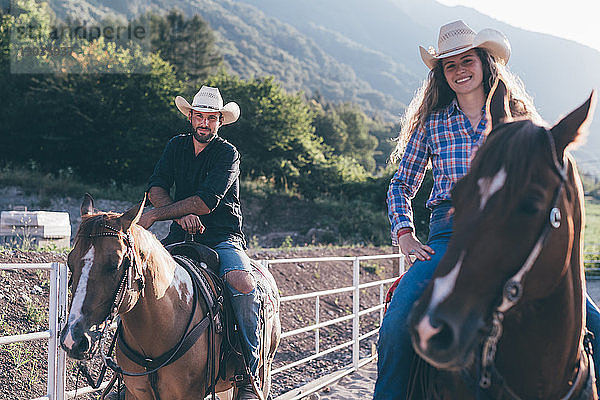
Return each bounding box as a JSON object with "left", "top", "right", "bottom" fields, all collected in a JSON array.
[{"left": 19, "top": 0, "right": 600, "bottom": 171}]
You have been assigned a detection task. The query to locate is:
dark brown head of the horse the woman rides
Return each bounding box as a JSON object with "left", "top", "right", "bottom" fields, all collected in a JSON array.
[{"left": 409, "top": 77, "right": 595, "bottom": 376}]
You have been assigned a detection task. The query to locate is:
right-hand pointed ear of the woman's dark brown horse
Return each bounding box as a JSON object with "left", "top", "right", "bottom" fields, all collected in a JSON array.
[{"left": 550, "top": 90, "right": 596, "bottom": 159}]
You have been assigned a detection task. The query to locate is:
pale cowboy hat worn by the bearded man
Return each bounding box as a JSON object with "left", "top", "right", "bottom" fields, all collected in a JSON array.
[{"left": 175, "top": 86, "right": 240, "bottom": 125}]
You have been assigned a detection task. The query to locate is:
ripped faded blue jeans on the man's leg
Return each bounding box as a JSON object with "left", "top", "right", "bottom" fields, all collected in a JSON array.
[{"left": 214, "top": 241, "right": 260, "bottom": 376}]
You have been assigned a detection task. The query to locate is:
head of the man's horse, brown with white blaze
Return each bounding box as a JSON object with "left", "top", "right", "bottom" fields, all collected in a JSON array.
[{"left": 60, "top": 194, "right": 144, "bottom": 359}]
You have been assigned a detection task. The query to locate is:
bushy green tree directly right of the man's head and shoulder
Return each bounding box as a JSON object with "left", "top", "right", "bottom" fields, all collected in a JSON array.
[{"left": 204, "top": 73, "right": 365, "bottom": 197}]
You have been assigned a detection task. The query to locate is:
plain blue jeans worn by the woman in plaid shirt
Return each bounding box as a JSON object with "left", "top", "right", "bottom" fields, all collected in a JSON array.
[{"left": 373, "top": 206, "right": 600, "bottom": 400}]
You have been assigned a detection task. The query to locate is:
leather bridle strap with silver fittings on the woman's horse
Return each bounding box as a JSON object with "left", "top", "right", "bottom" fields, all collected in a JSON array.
[{"left": 478, "top": 129, "right": 591, "bottom": 400}]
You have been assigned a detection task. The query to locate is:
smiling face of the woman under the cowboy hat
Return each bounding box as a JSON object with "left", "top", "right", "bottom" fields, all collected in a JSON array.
[{"left": 441, "top": 49, "right": 484, "bottom": 96}]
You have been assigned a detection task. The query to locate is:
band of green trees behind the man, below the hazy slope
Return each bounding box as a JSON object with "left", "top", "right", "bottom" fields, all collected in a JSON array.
[{"left": 0, "top": 0, "right": 418, "bottom": 244}]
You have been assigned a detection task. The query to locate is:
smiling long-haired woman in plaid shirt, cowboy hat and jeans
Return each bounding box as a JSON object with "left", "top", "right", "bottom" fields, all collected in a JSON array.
[{"left": 374, "top": 21, "right": 600, "bottom": 400}]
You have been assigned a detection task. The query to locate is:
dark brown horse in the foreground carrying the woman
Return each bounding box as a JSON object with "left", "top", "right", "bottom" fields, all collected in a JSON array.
[{"left": 409, "top": 82, "right": 597, "bottom": 399}]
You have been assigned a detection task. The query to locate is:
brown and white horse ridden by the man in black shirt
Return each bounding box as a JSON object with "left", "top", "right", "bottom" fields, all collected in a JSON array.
[{"left": 61, "top": 195, "right": 281, "bottom": 400}]
